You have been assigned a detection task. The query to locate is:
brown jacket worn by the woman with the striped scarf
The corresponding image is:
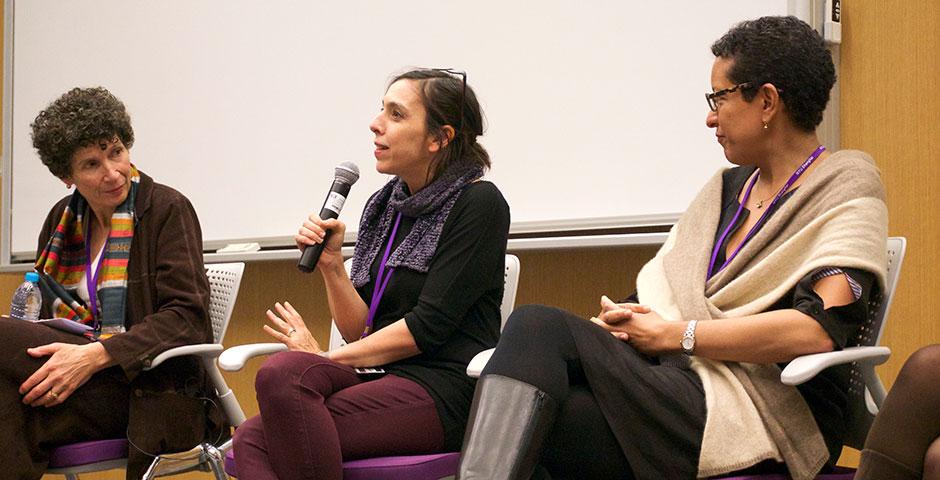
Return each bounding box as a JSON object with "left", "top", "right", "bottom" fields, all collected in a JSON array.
[{"left": 39, "top": 173, "right": 228, "bottom": 478}]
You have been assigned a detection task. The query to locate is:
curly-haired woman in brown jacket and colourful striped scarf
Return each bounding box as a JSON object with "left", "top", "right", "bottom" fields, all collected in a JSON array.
[{"left": 0, "top": 88, "right": 218, "bottom": 479}]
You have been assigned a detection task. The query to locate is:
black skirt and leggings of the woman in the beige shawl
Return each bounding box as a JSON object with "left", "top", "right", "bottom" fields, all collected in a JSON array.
[{"left": 483, "top": 305, "right": 705, "bottom": 479}]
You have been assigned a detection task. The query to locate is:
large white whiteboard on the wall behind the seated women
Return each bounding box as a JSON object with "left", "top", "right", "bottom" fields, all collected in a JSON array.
[{"left": 2, "top": 0, "right": 787, "bottom": 258}]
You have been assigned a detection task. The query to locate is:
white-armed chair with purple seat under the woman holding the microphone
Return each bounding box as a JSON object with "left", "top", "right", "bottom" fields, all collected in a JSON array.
[{"left": 219, "top": 255, "right": 519, "bottom": 480}]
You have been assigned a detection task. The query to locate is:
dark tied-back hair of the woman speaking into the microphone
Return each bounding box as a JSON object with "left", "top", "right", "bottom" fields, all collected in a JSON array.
[{"left": 390, "top": 69, "right": 490, "bottom": 183}]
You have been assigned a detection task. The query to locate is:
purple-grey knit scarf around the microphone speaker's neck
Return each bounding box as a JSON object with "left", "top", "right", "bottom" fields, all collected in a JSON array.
[{"left": 349, "top": 165, "right": 483, "bottom": 288}]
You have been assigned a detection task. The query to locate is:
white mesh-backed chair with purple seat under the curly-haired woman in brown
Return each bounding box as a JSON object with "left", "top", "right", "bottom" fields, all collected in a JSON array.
[{"left": 46, "top": 263, "right": 245, "bottom": 480}]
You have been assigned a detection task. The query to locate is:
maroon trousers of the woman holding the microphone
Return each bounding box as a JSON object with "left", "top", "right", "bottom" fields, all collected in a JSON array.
[{"left": 234, "top": 352, "right": 444, "bottom": 480}]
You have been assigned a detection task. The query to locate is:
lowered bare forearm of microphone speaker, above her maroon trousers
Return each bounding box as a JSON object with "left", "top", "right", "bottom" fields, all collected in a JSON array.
[{"left": 329, "top": 319, "right": 421, "bottom": 367}]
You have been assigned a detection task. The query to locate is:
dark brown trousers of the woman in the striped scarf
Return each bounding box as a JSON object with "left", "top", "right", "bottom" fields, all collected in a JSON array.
[{"left": 0, "top": 318, "right": 129, "bottom": 479}]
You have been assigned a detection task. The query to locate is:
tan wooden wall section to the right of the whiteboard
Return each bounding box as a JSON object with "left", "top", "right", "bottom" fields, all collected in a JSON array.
[{"left": 840, "top": 0, "right": 940, "bottom": 465}]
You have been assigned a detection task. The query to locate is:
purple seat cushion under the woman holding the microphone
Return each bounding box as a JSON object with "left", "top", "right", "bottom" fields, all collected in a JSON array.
[{"left": 225, "top": 450, "right": 460, "bottom": 480}]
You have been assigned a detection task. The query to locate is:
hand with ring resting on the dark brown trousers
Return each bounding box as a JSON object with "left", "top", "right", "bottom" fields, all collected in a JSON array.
[{"left": 19, "top": 342, "right": 112, "bottom": 407}]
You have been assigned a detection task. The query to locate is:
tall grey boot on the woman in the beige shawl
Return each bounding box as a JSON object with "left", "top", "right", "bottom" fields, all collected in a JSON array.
[{"left": 457, "top": 375, "right": 558, "bottom": 480}]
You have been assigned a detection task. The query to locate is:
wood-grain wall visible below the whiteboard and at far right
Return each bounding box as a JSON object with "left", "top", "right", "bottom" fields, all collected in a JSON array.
[{"left": 0, "top": 0, "right": 928, "bottom": 479}]
